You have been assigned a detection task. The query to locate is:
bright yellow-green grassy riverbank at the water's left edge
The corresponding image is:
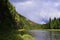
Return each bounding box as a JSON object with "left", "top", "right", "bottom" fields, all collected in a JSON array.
[{"left": 18, "top": 29, "right": 35, "bottom": 40}]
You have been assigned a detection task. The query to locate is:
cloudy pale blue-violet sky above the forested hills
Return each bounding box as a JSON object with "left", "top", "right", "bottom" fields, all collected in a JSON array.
[{"left": 10, "top": 0, "right": 60, "bottom": 24}]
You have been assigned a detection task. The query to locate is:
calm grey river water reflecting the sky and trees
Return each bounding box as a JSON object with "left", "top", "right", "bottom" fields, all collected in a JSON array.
[{"left": 29, "top": 30, "right": 60, "bottom": 40}]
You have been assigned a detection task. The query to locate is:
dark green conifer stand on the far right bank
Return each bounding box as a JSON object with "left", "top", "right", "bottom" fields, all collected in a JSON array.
[{"left": 43, "top": 18, "right": 60, "bottom": 29}]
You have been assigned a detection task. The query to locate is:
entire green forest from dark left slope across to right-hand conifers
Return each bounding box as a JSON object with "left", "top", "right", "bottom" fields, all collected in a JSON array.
[{"left": 0, "top": 0, "right": 60, "bottom": 40}]
